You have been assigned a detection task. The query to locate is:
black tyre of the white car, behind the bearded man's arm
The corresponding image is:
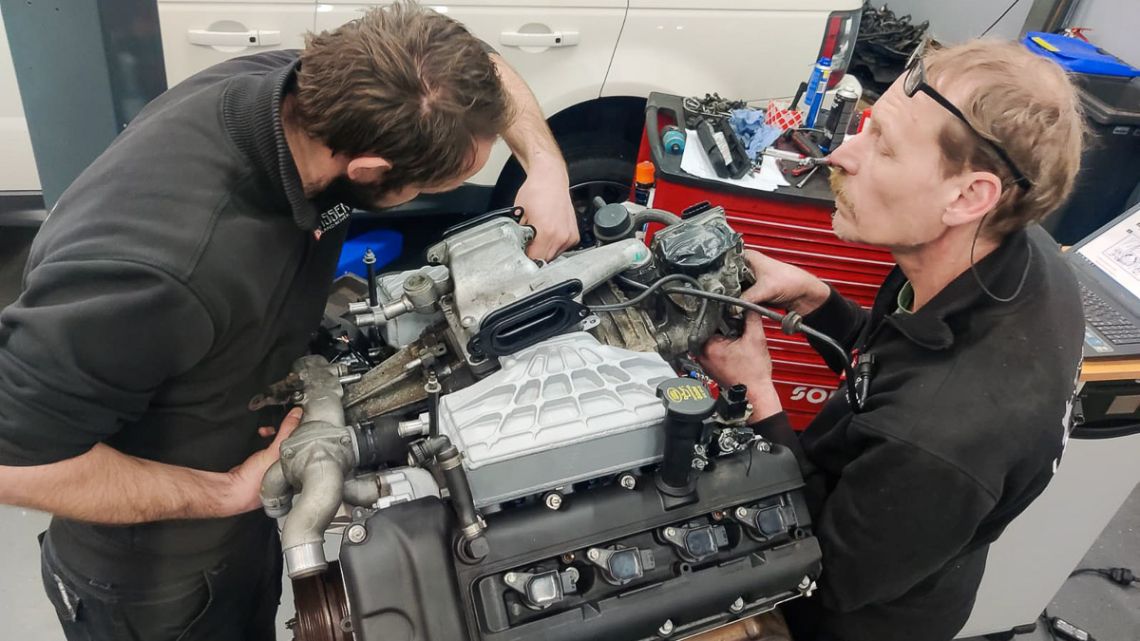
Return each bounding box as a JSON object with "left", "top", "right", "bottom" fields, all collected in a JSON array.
[{"left": 491, "top": 132, "right": 637, "bottom": 246}]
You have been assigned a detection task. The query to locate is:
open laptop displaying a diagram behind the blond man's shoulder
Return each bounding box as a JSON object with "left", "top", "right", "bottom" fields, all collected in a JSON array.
[{"left": 1066, "top": 204, "right": 1140, "bottom": 358}]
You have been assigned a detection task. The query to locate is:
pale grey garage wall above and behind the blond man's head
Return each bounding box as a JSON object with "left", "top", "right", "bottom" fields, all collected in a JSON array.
[{"left": 872, "top": 0, "right": 1140, "bottom": 67}]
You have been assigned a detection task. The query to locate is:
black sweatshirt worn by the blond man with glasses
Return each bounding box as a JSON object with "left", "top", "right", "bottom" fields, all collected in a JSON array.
[{"left": 757, "top": 227, "right": 1084, "bottom": 641}]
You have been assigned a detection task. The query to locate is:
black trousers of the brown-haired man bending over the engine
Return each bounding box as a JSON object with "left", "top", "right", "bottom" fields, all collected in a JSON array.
[{"left": 40, "top": 530, "right": 282, "bottom": 641}]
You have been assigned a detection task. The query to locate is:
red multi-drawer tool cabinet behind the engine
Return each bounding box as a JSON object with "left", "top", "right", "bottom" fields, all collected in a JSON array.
[{"left": 637, "top": 94, "right": 894, "bottom": 429}]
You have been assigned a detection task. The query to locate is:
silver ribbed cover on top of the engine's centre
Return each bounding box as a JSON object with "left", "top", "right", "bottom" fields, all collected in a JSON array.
[{"left": 430, "top": 332, "right": 676, "bottom": 508}]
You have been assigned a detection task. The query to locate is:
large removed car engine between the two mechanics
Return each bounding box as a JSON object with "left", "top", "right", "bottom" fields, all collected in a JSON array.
[{"left": 251, "top": 203, "right": 821, "bottom": 641}]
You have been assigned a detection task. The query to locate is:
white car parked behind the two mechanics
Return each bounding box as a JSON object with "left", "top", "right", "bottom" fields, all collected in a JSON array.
[{"left": 0, "top": 0, "right": 862, "bottom": 216}]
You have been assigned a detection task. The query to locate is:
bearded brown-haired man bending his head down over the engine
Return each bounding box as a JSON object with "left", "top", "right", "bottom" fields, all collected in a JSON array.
[{"left": 0, "top": 3, "right": 577, "bottom": 641}]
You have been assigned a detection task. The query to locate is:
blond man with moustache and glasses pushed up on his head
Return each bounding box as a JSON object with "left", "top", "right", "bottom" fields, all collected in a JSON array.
[{"left": 702, "top": 41, "right": 1084, "bottom": 641}]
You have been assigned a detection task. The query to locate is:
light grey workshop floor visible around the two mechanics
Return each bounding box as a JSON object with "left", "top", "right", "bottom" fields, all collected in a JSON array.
[{"left": 0, "top": 229, "right": 1140, "bottom": 641}]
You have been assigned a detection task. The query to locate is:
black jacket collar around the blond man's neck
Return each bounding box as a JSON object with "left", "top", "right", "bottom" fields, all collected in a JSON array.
[{"left": 871, "top": 229, "right": 1035, "bottom": 350}]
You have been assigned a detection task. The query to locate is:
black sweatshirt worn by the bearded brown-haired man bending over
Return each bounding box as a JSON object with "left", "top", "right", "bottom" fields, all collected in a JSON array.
[{"left": 0, "top": 51, "right": 348, "bottom": 584}]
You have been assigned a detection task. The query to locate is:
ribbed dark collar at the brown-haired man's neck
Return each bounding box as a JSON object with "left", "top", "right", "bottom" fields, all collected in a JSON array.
[{"left": 222, "top": 58, "right": 319, "bottom": 232}]
